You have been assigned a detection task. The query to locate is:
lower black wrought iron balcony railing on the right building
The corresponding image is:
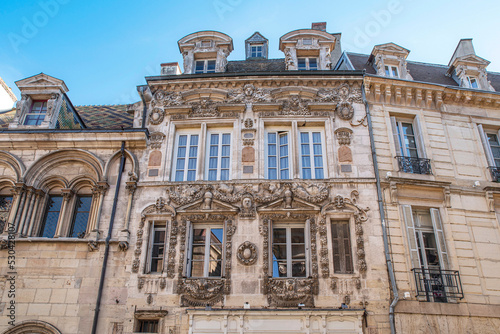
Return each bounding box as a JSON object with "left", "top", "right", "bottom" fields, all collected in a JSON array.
[{"left": 412, "top": 268, "right": 464, "bottom": 303}]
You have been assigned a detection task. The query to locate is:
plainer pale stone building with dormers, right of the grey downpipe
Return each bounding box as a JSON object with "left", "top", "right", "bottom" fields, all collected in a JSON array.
[{"left": 337, "top": 39, "right": 500, "bottom": 333}]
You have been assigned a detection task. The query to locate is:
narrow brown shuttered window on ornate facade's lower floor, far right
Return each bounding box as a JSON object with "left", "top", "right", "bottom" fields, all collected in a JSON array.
[{"left": 332, "top": 221, "right": 354, "bottom": 274}]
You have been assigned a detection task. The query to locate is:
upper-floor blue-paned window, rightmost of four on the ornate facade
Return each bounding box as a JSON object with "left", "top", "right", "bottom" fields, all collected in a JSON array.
[{"left": 300, "top": 132, "right": 324, "bottom": 179}]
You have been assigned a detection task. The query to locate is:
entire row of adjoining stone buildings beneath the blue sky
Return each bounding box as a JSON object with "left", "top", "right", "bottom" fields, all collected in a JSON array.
[{"left": 0, "top": 24, "right": 500, "bottom": 334}]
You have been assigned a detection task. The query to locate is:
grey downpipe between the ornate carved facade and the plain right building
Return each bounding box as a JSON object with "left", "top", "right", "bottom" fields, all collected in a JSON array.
[{"left": 361, "top": 83, "right": 399, "bottom": 334}]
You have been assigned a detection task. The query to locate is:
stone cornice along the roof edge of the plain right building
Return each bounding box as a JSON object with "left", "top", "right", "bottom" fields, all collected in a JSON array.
[{"left": 365, "top": 75, "right": 500, "bottom": 110}]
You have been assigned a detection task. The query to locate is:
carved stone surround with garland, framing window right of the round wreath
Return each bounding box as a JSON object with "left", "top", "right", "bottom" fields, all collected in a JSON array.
[{"left": 259, "top": 213, "right": 318, "bottom": 307}]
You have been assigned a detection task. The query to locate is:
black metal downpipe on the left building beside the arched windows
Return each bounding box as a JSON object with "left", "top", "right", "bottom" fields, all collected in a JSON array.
[{"left": 92, "top": 141, "right": 125, "bottom": 334}]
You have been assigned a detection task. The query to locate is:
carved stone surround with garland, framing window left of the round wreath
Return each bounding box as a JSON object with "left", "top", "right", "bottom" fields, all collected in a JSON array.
[{"left": 177, "top": 215, "right": 236, "bottom": 306}]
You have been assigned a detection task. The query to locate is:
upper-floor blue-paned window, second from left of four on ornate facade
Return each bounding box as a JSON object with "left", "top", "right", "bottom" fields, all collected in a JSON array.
[{"left": 207, "top": 133, "right": 231, "bottom": 181}]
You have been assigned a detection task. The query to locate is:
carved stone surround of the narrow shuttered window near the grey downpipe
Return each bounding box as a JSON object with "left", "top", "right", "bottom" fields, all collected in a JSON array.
[{"left": 319, "top": 190, "right": 370, "bottom": 278}]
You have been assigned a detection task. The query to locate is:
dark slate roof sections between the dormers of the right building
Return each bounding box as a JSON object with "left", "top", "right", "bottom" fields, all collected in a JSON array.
[{"left": 346, "top": 52, "right": 500, "bottom": 91}]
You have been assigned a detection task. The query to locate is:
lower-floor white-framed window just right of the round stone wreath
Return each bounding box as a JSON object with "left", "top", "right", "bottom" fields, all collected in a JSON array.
[{"left": 272, "top": 225, "right": 308, "bottom": 277}]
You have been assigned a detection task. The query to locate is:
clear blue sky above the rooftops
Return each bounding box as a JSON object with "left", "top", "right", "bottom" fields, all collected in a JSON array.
[{"left": 0, "top": 0, "right": 500, "bottom": 105}]
